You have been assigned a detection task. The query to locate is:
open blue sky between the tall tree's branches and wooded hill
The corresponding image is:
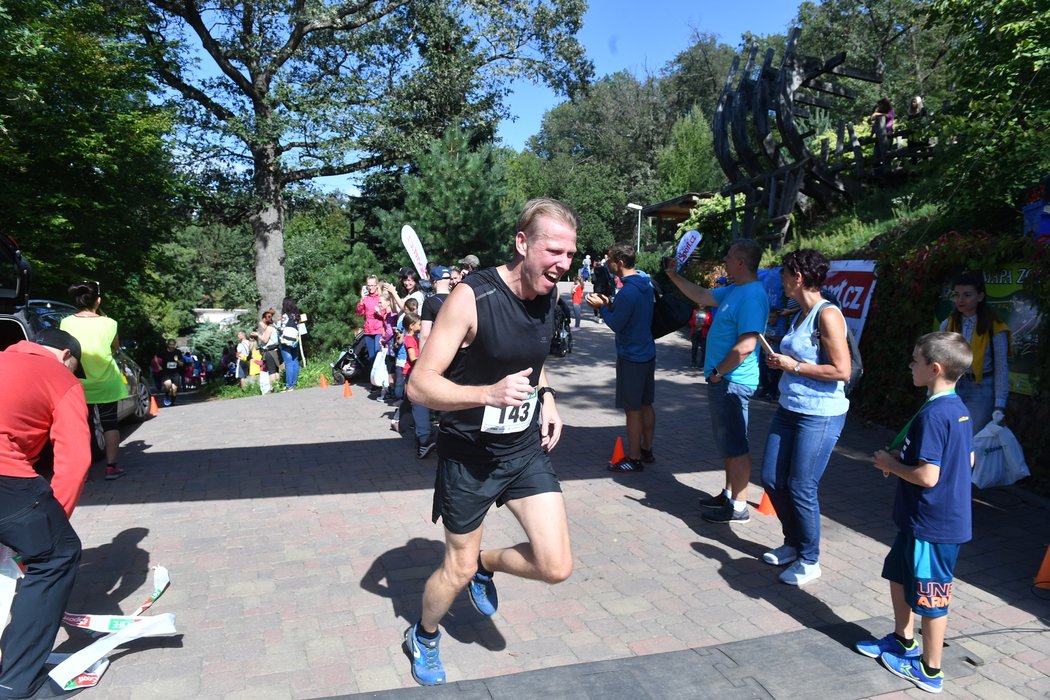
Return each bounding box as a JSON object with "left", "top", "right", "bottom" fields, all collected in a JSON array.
[{"left": 499, "top": 0, "right": 798, "bottom": 150}]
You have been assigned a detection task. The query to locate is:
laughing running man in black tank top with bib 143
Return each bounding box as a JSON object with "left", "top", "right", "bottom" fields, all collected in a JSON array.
[{"left": 404, "top": 199, "right": 576, "bottom": 685}]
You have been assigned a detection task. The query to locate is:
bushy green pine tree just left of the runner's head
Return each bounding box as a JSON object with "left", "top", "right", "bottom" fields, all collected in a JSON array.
[{"left": 378, "top": 129, "right": 516, "bottom": 267}]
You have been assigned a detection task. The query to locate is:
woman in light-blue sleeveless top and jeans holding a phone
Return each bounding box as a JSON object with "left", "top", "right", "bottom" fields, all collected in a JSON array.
[{"left": 762, "top": 249, "right": 851, "bottom": 586}]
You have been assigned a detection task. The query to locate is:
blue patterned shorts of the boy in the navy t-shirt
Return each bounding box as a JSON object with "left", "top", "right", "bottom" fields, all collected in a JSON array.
[{"left": 882, "top": 532, "right": 960, "bottom": 617}]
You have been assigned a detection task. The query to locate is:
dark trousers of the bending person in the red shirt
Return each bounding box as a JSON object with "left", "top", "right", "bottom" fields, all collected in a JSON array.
[{"left": 0, "top": 476, "right": 81, "bottom": 698}]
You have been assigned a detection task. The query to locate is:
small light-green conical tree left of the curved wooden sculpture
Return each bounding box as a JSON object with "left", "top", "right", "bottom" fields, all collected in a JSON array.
[{"left": 657, "top": 106, "right": 727, "bottom": 199}]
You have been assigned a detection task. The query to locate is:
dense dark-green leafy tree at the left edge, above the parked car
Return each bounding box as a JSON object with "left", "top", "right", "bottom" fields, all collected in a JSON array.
[{"left": 0, "top": 0, "right": 179, "bottom": 323}]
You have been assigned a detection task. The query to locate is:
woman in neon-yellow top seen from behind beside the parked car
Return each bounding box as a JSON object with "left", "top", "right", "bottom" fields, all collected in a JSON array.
[{"left": 59, "top": 282, "right": 128, "bottom": 481}]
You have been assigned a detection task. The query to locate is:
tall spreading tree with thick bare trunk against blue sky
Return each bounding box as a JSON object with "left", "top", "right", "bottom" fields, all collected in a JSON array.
[{"left": 140, "top": 0, "right": 591, "bottom": 314}]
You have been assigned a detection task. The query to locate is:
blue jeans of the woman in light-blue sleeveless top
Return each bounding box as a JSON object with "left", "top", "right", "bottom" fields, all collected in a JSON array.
[{"left": 762, "top": 407, "right": 846, "bottom": 564}]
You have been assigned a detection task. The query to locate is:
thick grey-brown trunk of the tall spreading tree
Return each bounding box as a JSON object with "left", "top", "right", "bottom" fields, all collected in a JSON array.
[{"left": 249, "top": 146, "right": 285, "bottom": 313}]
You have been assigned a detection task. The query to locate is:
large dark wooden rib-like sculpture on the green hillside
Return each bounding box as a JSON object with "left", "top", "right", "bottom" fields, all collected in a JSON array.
[{"left": 712, "top": 27, "right": 912, "bottom": 247}]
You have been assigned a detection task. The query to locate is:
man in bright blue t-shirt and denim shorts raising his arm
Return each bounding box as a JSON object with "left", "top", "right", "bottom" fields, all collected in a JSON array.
[{"left": 665, "top": 238, "right": 770, "bottom": 523}]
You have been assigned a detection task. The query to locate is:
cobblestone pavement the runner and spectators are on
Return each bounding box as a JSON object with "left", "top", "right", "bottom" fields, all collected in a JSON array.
[{"left": 61, "top": 285, "right": 1050, "bottom": 699}]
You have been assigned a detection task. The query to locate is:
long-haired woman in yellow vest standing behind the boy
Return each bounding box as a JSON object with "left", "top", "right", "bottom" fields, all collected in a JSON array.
[{"left": 941, "top": 270, "right": 1010, "bottom": 433}]
